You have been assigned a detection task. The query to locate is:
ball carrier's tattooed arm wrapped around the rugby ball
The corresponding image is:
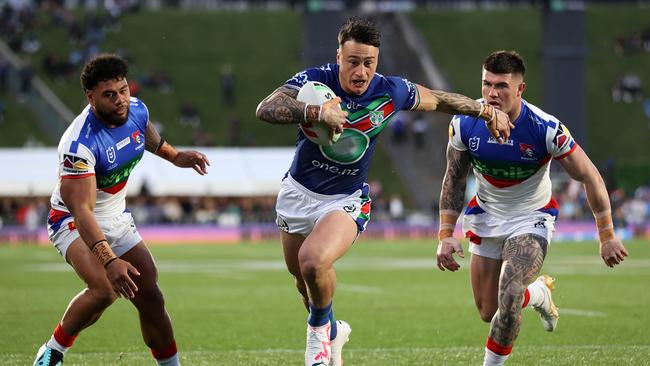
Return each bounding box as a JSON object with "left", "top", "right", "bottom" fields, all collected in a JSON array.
[{"left": 255, "top": 86, "right": 347, "bottom": 133}]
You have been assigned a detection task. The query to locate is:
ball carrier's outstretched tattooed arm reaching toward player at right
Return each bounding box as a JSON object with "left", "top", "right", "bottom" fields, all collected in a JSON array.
[{"left": 416, "top": 84, "right": 515, "bottom": 143}]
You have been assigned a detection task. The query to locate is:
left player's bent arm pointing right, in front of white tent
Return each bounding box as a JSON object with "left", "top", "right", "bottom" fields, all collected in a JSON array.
[{"left": 144, "top": 121, "right": 210, "bottom": 175}]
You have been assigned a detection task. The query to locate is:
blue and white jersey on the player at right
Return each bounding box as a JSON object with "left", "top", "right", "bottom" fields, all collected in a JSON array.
[{"left": 449, "top": 100, "right": 578, "bottom": 217}]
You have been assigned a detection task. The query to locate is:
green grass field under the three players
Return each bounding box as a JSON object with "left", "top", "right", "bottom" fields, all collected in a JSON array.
[{"left": 0, "top": 240, "right": 650, "bottom": 366}]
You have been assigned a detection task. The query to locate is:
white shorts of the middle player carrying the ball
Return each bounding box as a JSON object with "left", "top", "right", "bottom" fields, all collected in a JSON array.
[{"left": 275, "top": 174, "right": 371, "bottom": 236}]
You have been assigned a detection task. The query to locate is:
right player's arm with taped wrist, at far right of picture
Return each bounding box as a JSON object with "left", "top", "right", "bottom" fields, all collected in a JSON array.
[{"left": 559, "top": 146, "right": 628, "bottom": 267}]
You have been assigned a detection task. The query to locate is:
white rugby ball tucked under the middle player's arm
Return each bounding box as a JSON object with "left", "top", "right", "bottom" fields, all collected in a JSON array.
[{"left": 296, "top": 81, "right": 341, "bottom": 146}]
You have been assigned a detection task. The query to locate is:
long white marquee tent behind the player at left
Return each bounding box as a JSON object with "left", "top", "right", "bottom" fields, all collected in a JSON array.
[{"left": 0, "top": 148, "right": 294, "bottom": 196}]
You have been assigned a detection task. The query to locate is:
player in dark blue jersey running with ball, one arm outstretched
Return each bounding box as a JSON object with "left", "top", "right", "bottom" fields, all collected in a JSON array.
[{"left": 256, "top": 18, "right": 510, "bottom": 366}]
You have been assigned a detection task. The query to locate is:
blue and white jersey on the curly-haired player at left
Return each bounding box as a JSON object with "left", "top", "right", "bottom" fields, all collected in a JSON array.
[{"left": 48, "top": 97, "right": 149, "bottom": 226}]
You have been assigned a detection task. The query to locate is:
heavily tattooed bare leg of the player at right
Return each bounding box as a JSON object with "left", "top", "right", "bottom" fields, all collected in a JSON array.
[{"left": 490, "top": 234, "right": 548, "bottom": 346}]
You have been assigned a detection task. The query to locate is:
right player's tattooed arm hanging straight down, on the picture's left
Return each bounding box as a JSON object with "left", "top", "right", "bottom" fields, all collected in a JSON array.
[{"left": 436, "top": 144, "right": 471, "bottom": 272}]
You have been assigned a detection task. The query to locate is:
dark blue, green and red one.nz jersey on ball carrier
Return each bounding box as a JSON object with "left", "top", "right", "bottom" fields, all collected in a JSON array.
[{"left": 285, "top": 64, "right": 420, "bottom": 195}]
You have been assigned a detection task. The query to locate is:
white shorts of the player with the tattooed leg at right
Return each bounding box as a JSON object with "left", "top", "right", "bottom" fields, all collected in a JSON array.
[{"left": 463, "top": 196, "right": 557, "bottom": 259}]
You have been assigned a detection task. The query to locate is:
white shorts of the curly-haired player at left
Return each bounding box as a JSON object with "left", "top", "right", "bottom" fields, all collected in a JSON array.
[{"left": 47, "top": 210, "right": 142, "bottom": 260}]
